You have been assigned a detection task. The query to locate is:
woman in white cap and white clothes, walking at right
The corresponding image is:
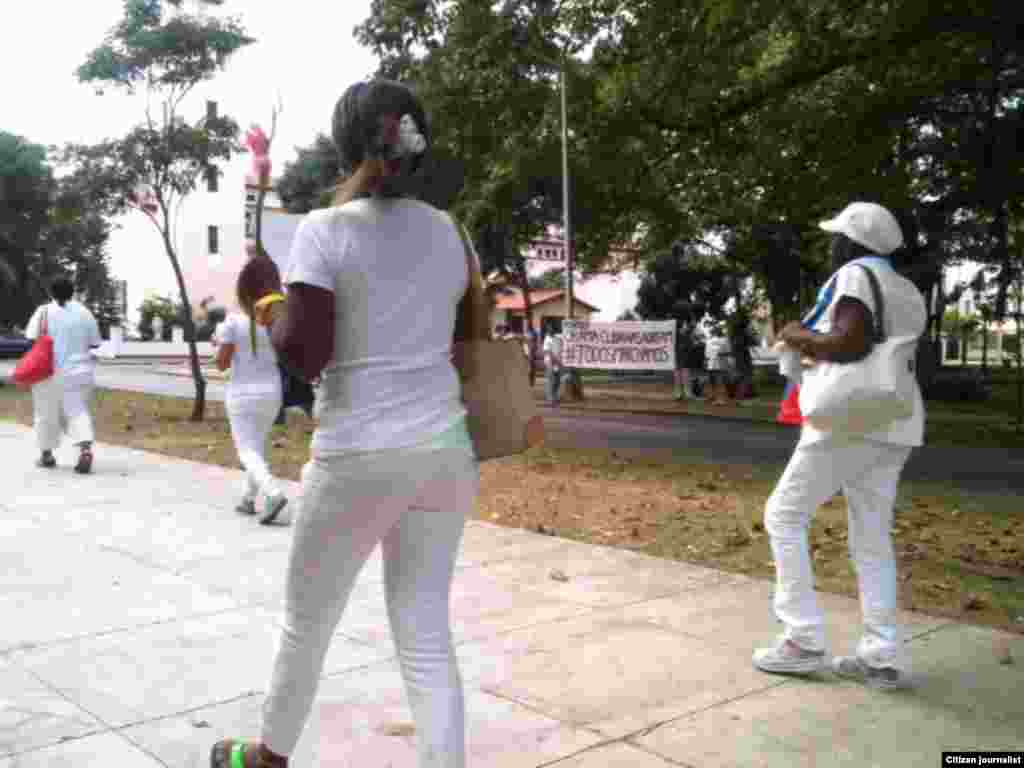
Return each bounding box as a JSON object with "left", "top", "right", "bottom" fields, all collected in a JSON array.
[{"left": 754, "top": 203, "right": 928, "bottom": 688}]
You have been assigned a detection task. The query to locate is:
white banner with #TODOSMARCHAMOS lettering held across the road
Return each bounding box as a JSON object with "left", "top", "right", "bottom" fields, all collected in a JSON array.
[{"left": 562, "top": 319, "right": 676, "bottom": 371}]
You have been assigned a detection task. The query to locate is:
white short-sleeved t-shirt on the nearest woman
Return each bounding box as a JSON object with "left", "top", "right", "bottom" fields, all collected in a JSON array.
[{"left": 285, "top": 198, "right": 468, "bottom": 456}]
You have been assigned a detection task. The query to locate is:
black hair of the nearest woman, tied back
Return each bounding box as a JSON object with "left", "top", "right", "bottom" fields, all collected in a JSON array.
[{"left": 331, "top": 79, "right": 431, "bottom": 201}]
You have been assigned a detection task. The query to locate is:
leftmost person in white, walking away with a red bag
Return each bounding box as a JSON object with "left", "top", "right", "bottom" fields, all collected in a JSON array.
[{"left": 25, "top": 278, "right": 102, "bottom": 474}]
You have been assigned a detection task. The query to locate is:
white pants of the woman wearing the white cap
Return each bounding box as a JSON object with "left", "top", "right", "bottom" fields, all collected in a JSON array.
[{"left": 765, "top": 439, "right": 910, "bottom": 669}]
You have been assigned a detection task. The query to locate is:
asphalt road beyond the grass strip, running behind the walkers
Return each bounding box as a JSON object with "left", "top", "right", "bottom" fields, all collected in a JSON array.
[{"left": 8, "top": 360, "right": 1024, "bottom": 494}]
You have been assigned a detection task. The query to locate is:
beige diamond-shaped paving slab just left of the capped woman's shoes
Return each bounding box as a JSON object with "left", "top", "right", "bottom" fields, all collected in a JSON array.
[{"left": 460, "top": 611, "right": 778, "bottom": 738}]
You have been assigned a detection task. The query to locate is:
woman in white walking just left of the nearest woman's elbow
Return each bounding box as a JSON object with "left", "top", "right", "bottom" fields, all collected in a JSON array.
[{"left": 214, "top": 261, "right": 288, "bottom": 525}]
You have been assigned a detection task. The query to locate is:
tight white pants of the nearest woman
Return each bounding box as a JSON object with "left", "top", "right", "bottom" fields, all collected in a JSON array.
[{"left": 262, "top": 447, "right": 479, "bottom": 768}]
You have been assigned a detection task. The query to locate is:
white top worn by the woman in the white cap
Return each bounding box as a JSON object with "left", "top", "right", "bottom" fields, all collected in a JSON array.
[{"left": 800, "top": 258, "right": 928, "bottom": 446}]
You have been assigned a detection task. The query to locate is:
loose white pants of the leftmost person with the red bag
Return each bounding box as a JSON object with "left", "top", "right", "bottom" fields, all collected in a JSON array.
[{"left": 32, "top": 366, "right": 96, "bottom": 451}]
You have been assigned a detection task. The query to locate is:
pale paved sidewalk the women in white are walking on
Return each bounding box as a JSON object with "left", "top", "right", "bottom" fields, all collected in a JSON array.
[{"left": 0, "top": 422, "right": 1024, "bottom": 768}]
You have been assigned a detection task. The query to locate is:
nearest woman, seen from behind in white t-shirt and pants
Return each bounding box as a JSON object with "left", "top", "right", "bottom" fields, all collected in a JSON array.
[{"left": 211, "top": 80, "right": 486, "bottom": 768}]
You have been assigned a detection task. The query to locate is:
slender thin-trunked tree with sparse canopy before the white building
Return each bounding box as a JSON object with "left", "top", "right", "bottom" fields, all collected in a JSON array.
[{"left": 76, "top": 0, "right": 254, "bottom": 421}]
